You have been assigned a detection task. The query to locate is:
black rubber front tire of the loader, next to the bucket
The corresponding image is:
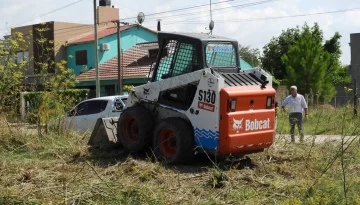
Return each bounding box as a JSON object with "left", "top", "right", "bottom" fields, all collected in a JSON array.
[{"left": 117, "top": 105, "right": 155, "bottom": 153}]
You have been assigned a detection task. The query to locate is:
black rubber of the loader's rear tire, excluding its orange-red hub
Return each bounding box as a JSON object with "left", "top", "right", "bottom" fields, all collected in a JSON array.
[{"left": 153, "top": 118, "right": 195, "bottom": 164}]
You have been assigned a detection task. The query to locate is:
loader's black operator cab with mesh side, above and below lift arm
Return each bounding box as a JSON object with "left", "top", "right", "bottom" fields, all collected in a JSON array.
[{"left": 150, "top": 32, "right": 240, "bottom": 110}]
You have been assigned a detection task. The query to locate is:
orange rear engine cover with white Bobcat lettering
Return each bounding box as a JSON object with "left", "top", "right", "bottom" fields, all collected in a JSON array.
[{"left": 219, "top": 86, "right": 275, "bottom": 154}]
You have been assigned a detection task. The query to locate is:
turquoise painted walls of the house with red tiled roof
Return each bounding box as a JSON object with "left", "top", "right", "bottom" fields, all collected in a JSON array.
[{"left": 67, "top": 27, "right": 157, "bottom": 75}]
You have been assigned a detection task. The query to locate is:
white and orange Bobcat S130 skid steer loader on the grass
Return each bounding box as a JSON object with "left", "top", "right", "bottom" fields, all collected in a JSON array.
[{"left": 90, "top": 32, "right": 275, "bottom": 163}]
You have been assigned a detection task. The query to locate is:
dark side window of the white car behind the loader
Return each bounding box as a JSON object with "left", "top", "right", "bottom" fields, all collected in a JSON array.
[{"left": 71, "top": 100, "right": 108, "bottom": 116}]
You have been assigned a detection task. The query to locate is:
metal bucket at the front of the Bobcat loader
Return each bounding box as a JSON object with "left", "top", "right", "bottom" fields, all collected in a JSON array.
[{"left": 88, "top": 117, "right": 119, "bottom": 149}]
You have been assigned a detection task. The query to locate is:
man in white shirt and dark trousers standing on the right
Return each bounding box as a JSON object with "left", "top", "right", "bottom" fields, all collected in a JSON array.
[{"left": 282, "top": 86, "right": 308, "bottom": 142}]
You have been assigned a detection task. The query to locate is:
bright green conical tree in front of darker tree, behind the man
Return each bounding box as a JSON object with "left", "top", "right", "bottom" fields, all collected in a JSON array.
[{"left": 282, "top": 24, "right": 336, "bottom": 99}]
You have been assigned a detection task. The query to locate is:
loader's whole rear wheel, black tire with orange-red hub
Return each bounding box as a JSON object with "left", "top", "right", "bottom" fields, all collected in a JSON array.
[{"left": 153, "top": 118, "right": 194, "bottom": 164}]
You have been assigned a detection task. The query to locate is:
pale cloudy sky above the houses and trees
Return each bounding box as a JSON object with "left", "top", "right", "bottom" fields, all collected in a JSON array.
[{"left": 0, "top": 0, "right": 360, "bottom": 64}]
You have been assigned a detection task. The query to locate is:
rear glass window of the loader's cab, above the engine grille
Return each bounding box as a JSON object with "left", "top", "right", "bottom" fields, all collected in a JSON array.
[{"left": 205, "top": 43, "right": 236, "bottom": 67}]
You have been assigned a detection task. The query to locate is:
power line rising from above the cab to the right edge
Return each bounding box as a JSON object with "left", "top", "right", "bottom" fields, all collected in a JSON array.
[{"left": 164, "top": 8, "right": 360, "bottom": 25}]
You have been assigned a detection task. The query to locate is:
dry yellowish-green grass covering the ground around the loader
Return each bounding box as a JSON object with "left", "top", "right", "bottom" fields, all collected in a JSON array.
[{"left": 0, "top": 106, "right": 360, "bottom": 205}]
